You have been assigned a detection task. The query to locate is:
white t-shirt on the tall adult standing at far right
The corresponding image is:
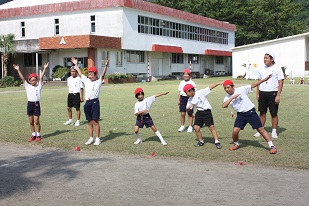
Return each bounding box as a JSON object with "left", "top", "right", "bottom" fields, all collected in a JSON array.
[{"left": 258, "top": 64, "right": 284, "bottom": 92}]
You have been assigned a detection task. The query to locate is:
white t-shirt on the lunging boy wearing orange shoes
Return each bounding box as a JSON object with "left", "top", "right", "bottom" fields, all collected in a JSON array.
[{"left": 223, "top": 85, "right": 254, "bottom": 112}]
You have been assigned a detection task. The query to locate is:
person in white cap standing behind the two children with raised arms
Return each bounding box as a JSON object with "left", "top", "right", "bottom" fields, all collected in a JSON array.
[{"left": 63, "top": 66, "right": 84, "bottom": 126}]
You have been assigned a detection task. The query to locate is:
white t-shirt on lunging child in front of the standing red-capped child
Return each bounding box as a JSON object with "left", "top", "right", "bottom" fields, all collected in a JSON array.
[{"left": 187, "top": 87, "right": 212, "bottom": 111}]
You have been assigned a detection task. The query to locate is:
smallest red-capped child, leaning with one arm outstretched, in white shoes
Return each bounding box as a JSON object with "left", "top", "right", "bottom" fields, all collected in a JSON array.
[{"left": 134, "top": 88, "right": 169, "bottom": 146}]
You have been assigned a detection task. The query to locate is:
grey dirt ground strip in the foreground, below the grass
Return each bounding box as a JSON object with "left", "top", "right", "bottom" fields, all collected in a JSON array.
[{"left": 0, "top": 143, "right": 309, "bottom": 206}]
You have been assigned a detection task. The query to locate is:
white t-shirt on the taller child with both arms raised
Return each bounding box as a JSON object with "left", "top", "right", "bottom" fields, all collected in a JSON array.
[{"left": 81, "top": 74, "right": 103, "bottom": 100}]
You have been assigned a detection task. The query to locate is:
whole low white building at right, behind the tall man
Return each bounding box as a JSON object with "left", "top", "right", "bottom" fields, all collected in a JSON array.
[{"left": 232, "top": 33, "right": 309, "bottom": 79}]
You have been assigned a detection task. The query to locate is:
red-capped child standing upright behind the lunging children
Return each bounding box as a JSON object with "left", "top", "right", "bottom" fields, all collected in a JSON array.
[{"left": 178, "top": 69, "right": 196, "bottom": 132}]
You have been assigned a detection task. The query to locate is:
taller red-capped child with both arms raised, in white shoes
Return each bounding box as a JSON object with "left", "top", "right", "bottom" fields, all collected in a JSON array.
[{"left": 71, "top": 57, "right": 109, "bottom": 145}]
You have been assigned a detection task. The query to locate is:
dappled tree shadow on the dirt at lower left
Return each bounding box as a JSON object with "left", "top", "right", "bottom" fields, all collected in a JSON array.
[{"left": 0, "top": 151, "right": 112, "bottom": 200}]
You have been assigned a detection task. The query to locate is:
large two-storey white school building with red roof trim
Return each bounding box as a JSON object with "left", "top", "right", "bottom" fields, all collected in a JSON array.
[{"left": 0, "top": 0, "right": 236, "bottom": 78}]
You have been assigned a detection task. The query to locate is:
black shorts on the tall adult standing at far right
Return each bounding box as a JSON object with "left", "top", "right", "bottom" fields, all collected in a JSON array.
[{"left": 258, "top": 91, "right": 279, "bottom": 114}]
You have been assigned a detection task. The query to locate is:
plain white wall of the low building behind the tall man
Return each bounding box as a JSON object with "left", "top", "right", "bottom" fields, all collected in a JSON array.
[{"left": 232, "top": 36, "right": 306, "bottom": 78}]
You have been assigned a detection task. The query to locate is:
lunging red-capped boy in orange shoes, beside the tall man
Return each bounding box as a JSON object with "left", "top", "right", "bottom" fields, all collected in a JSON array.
[{"left": 222, "top": 75, "right": 277, "bottom": 154}]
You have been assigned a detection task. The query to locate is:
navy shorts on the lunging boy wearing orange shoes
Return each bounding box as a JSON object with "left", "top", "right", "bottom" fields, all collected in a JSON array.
[{"left": 234, "top": 108, "right": 262, "bottom": 130}]
